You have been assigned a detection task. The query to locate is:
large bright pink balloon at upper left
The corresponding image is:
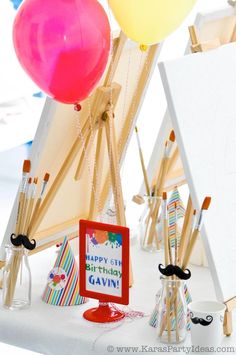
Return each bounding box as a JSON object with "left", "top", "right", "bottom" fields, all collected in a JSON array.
[{"left": 13, "top": 0, "right": 110, "bottom": 103}]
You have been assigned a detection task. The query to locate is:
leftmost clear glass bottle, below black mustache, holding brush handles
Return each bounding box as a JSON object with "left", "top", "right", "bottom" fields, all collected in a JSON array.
[{"left": 3, "top": 245, "right": 31, "bottom": 310}]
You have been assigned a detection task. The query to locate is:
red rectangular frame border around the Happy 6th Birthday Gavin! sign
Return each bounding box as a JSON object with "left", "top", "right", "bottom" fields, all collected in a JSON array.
[{"left": 79, "top": 220, "right": 130, "bottom": 305}]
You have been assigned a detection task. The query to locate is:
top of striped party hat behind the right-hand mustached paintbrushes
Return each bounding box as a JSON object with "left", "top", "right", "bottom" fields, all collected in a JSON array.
[{"left": 168, "top": 187, "right": 185, "bottom": 247}]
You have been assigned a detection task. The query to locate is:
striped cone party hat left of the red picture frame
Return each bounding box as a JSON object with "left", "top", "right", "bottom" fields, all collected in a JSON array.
[{"left": 42, "top": 237, "right": 87, "bottom": 306}]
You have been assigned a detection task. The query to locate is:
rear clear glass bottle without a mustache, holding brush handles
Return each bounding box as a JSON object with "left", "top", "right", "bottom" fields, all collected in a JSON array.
[{"left": 138, "top": 196, "right": 162, "bottom": 252}]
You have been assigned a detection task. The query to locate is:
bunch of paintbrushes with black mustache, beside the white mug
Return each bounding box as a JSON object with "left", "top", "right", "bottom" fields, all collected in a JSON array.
[{"left": 158, "top": 192, "right": 211, "bottom": 343}]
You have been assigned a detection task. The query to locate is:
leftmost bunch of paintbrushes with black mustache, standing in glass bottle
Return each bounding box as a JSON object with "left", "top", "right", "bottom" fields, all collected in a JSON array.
[{"left": 4, "top": 160, "right": 49, "bottom": 307}]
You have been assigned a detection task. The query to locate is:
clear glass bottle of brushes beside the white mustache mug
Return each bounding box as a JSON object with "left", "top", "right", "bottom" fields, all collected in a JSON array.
[{"left": 157, "top": 277, "right": 188, "bottom": 344}]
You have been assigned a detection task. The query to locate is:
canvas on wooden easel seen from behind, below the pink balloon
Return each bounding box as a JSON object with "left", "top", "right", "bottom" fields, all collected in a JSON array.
[{"left": 0, "top": 33, "right": 159, "bottom": 265}]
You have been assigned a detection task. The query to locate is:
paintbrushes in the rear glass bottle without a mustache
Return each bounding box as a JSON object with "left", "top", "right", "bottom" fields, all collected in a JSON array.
[{"left": 135, "top": 127, "right": 175, "bottom": 250}]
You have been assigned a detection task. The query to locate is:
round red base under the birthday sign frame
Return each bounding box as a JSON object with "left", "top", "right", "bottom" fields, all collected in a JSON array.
[{"left": 83, "top": 301, "right": 125, "bottom": 323}]
